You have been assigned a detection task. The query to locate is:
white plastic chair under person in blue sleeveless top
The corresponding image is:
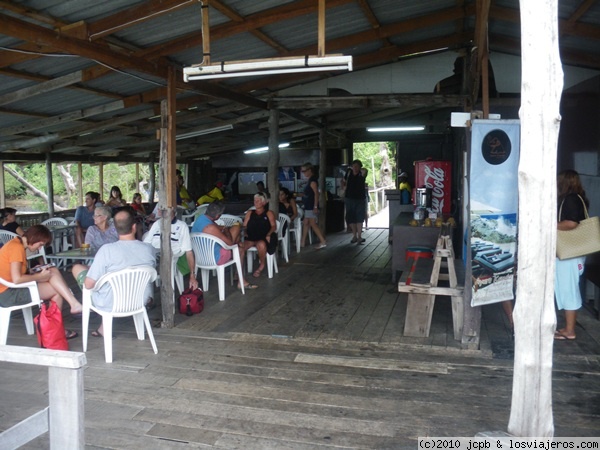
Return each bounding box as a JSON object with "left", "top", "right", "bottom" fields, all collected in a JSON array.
[{"left": 190, "top": 233, "right": 246, "bottom": 301}]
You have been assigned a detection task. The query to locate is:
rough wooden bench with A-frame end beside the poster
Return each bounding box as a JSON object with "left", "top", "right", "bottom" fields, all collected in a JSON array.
[{"left": 398, "top": 231, "right": 465, "bottom": 340}]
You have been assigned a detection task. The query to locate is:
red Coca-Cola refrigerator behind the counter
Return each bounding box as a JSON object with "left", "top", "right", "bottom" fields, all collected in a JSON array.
[{"left": 413, "top": 159, "right": 452, "bottom": 214}]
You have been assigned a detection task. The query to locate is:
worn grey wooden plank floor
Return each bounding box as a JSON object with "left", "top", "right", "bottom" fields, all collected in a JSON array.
[{"left": 0, "top": 229, "right": 600, "bottom": 450}]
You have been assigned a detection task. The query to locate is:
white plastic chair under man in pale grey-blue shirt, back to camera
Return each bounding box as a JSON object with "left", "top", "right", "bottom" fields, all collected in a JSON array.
[{"left": 82, "top": 266, "right": 158, "bottom": 363}]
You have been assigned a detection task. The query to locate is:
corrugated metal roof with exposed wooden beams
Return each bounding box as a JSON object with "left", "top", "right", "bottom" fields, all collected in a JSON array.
[{"left": 0, "top": 0, "right": 600, "bottom": 162}]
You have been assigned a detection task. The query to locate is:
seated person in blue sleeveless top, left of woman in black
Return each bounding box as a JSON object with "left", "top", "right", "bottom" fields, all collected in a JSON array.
[{"left": 192, "top": 200, "right": 258, "bottom": 289}]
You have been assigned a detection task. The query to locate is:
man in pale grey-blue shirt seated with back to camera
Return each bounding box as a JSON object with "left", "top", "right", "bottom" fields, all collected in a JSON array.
[{"left": 73, "top": 209, "right": 156, "bottom": 337}]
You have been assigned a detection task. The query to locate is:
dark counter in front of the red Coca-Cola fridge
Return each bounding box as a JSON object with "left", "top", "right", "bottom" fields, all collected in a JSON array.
[{"left": 392, "top": 212, "right": 440, "bottom": 283}]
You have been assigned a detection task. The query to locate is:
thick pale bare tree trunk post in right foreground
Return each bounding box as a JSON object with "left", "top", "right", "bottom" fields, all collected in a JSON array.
[{"left": 508, "top": 0, "right": 563, "bottom": 437}]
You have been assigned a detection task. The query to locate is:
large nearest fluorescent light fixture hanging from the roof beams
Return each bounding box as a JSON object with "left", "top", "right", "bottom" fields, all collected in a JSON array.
[{"left": 183, "top": 55, "right": 352, "bottom": 82}]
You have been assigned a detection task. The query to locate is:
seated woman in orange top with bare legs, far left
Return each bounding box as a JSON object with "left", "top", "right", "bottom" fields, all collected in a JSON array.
[{"left": 0, "top": 225, "right": 82, "bottom": 339}]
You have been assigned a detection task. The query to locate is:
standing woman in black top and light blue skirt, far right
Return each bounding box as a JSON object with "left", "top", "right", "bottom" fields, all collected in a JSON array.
[{"left": 554, "top": 170, "right": 589, "bottom": 341}]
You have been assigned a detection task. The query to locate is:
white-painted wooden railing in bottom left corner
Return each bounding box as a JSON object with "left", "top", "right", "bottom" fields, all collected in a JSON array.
[{"left": 0, "top": 345, "right": 87, "bottom": 450}]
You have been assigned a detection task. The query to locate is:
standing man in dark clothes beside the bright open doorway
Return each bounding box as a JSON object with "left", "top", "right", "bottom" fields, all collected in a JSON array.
[{"left": 342, "top": 159, "right": 365, "bottom": 245}]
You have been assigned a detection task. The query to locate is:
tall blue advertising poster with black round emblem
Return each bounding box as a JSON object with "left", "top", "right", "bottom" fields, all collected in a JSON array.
[{"left": 469, "top": 120, "right": 520, "bottom": 306}]
